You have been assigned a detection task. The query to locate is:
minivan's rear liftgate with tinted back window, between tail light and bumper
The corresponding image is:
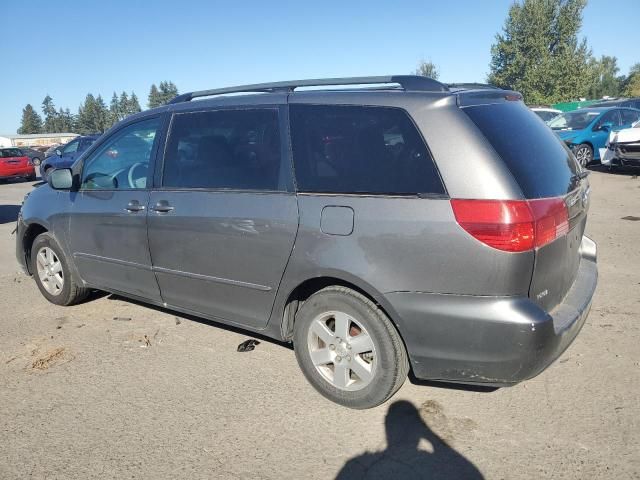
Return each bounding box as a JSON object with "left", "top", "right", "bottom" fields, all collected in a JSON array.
[{"left": 463, "top": 100, "right": 589, "bottom": 310}]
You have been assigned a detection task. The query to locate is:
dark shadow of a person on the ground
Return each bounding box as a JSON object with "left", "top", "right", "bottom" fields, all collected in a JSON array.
[{"left": 336, "top": 400, "right": 484, "bottom": 480}]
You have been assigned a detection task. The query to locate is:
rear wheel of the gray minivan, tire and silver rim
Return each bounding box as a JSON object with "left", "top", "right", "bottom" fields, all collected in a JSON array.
[{"left": 294, "top": 286, "right": 409, "bottom": 409}]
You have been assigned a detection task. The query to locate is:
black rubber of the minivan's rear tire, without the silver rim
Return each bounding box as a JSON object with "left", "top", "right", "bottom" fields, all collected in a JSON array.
[{"left": 294, "top": 290, "right": 400, "bottom": 409}]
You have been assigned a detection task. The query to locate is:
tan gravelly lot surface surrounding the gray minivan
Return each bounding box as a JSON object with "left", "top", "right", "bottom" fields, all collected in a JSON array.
[{"left": 0, "top": 172, "right": 640, "bottom": 479}]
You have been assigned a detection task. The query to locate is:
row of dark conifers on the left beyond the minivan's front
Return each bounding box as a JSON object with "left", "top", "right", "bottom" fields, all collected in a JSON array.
[{"left": 18, "top": 81, "right": 178, "bottom": 135}]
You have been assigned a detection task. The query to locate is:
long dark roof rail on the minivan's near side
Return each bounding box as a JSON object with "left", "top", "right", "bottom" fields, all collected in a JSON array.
[{"left": 169, "top": 75, "right": 449, "bottom": 104}]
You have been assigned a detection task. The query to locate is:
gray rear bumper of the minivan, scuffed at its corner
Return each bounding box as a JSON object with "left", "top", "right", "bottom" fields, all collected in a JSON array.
[{"left": 385, "top": 237, "right": 598, "bottom": 386}]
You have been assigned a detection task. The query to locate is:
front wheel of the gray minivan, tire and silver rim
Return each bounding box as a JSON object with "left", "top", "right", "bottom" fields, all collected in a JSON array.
[{"left": 31, "top": 233, "right": 89, "bottom": 306}]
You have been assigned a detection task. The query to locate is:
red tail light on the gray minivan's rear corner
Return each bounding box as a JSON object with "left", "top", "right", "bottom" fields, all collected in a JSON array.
[{"left": 451, "top": 197, "right": 569, "bottom": 252}]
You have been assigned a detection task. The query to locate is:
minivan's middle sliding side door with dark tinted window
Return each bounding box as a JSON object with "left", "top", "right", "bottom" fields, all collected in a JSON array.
[{"left": 148, "top": 107, "right": 298, "bottom": 328}]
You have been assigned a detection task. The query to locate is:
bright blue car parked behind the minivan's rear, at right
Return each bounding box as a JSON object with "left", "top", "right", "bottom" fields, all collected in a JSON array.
[{"left": 549, "top": 107, "right": 640, "bottom": 167}]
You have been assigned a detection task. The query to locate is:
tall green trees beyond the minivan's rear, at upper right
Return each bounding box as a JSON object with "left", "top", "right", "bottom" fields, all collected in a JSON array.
[{"left": 415, "top": 0, "right": 640, "bottom": 104}]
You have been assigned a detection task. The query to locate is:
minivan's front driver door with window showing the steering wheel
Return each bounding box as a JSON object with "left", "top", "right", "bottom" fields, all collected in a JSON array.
[{"left": 69, "top": 117, "right": 161, "bottom": 302}]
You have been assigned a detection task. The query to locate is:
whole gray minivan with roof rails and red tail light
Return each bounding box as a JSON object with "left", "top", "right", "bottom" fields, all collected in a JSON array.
[{"left": 17, "top": 76, "right": 597, "bottom": 408}]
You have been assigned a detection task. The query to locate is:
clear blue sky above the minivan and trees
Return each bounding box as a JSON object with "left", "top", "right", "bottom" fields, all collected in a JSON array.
[{"left": 0, "top": 0, "right": 640, "bottom": 134}]
